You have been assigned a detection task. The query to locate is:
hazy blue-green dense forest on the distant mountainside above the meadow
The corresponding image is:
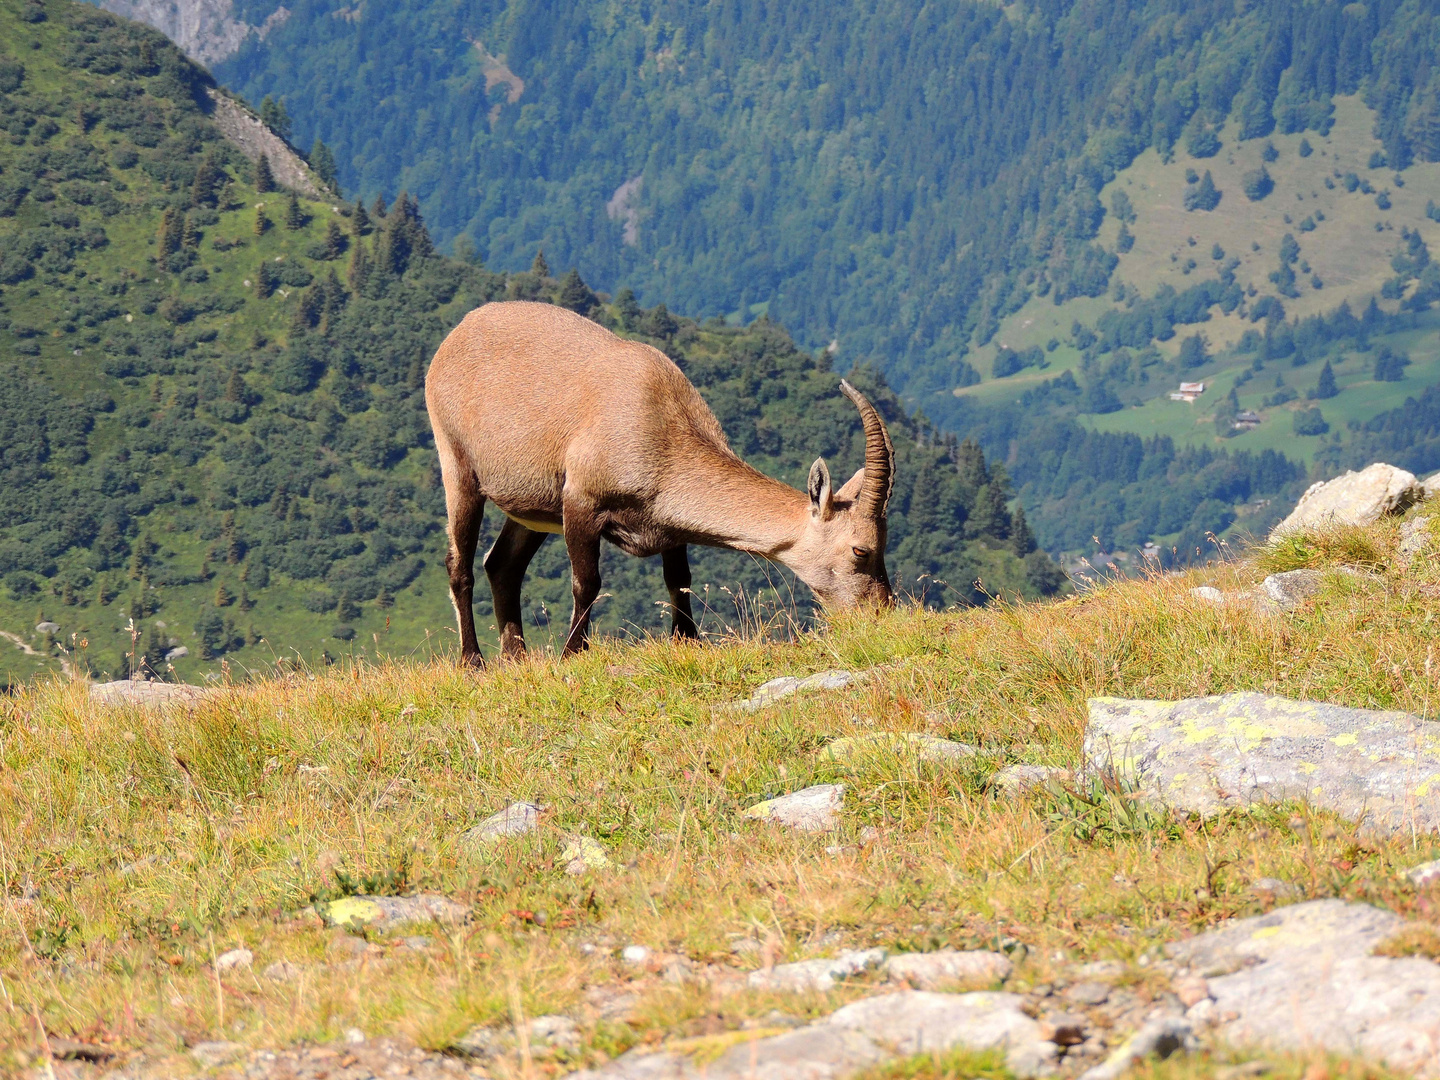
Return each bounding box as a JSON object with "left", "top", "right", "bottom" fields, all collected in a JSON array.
[{"left": 197, "top": 0, "right": 1440, "bottom": 395}]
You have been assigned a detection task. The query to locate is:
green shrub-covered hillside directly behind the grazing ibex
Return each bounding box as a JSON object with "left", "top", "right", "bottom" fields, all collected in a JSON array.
[{"left": 0, "top": 0, "right": 1063, "bottom": 688}]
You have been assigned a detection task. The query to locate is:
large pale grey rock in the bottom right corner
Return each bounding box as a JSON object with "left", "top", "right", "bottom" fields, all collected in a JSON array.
[{"left": 1169, "top": 900, "right": 1440, "bottom": 1077}]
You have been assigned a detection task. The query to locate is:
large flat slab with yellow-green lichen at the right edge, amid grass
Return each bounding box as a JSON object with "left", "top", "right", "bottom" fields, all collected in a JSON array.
[{"left": 1084, "top": 693, "right": 1440, "bottom": 835}]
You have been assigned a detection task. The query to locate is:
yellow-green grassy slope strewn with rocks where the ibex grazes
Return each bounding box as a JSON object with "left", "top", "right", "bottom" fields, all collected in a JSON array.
[{"left": 0, "top": 521, "right": 1440, "bottom": 1080}]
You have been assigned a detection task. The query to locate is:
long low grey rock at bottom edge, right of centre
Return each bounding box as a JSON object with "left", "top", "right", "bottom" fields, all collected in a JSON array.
[{"left": 572, "top": 991, "right": 1056, "bottom": 1080}]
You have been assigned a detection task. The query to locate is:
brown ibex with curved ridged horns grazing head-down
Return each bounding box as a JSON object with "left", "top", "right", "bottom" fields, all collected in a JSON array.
[{"left": 425, "top": 301, "right": 894, "bottom": 664}]
